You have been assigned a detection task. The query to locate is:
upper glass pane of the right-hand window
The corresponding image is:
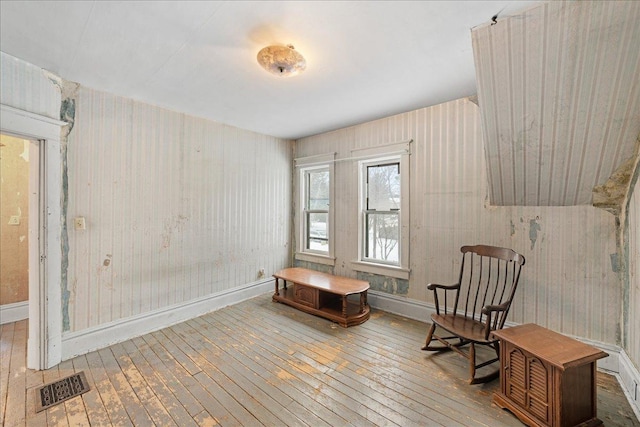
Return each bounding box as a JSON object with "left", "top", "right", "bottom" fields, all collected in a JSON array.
[{"left": 367, "top": 163, "right": 400, "bottom": 211}]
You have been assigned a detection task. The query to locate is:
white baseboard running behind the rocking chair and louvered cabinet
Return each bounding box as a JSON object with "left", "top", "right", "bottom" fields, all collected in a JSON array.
[{"left": 368, "top": 291, "right": 640, "bottom": 420}]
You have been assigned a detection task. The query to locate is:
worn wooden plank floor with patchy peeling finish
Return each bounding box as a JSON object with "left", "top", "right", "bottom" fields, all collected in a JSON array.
[{"left": 0, "top": 295, "right": 640, "bottom": 427}]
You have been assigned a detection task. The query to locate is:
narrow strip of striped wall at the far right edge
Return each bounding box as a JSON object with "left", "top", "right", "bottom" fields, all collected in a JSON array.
[{"left": 625, "top": 177, "right": 640, "bottom": 369}]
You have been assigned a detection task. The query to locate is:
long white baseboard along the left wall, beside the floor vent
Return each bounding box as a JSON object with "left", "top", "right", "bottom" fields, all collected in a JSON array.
[{"left": 62, "top": 278, "right": 274, "bottom": 360}]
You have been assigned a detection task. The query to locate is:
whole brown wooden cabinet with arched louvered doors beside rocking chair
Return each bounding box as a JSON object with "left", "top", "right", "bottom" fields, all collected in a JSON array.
[{"left": 493, "top": 324, "right": 607, "bottom": 427}]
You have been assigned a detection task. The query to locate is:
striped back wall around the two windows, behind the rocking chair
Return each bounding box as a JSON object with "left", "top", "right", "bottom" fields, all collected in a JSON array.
[{"left": 296, "top": 99, "right": 621, "bottom": 343}]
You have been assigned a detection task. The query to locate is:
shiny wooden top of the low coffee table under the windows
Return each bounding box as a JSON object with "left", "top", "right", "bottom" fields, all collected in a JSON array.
[{"left": 273, "top": 267, "right": 369, "bottom": 295}]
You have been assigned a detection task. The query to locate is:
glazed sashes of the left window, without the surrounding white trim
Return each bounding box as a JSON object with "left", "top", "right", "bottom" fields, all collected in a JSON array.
[{"left": 303, "top": 168, "right": 330, "bottom": 254}]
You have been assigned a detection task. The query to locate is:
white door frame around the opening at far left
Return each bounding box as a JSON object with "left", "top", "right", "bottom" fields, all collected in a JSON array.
[{"left": 0, "top": 104, "right": 66, "bottom": 370}]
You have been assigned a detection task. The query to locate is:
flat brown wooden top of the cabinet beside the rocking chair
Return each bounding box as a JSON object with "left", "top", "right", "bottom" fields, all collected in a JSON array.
[{"left": 493, "top": 323, "right": 608, "bottom": 370}]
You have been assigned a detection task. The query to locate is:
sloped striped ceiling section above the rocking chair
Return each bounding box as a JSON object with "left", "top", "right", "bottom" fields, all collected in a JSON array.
[{"left": 472, "top": 1, "right": 640, "bottom": 206}]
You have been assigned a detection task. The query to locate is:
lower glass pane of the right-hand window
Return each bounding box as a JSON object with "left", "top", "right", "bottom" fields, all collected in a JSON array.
[{"left": 366, "top": 213, "right": 400, "bottom": 264}]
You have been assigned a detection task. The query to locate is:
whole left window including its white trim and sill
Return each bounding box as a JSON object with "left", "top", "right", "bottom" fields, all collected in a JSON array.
[{"left": 294, "top": 153, "right": 335, "bottom": 265}]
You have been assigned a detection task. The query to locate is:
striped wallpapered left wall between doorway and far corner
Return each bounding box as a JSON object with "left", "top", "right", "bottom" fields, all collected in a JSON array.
[{"left": 63, "top": 88, "right": 292, "bottom": 331}]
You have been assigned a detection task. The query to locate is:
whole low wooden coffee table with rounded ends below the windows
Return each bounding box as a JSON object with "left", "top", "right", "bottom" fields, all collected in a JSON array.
[{"left": 273, "top": 267, "right": 370, "bottom": 328}]
